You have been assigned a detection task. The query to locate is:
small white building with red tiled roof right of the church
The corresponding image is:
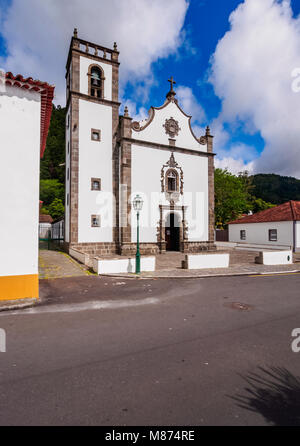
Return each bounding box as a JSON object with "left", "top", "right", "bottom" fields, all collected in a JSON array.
[{"left": 228, "top": 201, "right": 300, "bottom": 252}]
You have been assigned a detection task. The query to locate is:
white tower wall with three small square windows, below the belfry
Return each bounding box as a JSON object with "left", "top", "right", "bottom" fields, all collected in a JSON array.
[{"left": 78, "top": 100, "right": 113, "bottom": 243}]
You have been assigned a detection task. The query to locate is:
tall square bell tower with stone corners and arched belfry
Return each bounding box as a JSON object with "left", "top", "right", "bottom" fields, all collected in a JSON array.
[{"left": 65, "top": 29, "right": 120, "bottom": 254}]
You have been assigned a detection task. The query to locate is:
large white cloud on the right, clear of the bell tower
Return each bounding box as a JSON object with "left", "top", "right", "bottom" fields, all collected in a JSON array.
[{"left": 210, "top": 0, "right": 300, "bottom": 177}]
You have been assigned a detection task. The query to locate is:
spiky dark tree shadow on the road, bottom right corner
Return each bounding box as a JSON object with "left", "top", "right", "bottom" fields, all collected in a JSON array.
[{"left": 230, "top": 367, "right": 300, "bottom": 426}]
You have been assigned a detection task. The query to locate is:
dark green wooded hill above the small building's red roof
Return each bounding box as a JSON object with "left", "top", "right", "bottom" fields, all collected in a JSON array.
[{"left": 252, "top": 174, "right": 300, "bottom": 205}]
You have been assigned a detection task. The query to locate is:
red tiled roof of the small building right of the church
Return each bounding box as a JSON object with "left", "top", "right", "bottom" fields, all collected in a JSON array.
[{"left": 229, "top": 201, "right": 300, "bottom": 225}]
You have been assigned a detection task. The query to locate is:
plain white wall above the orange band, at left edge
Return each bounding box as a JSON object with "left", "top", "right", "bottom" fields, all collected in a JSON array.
[{"left": 0, "top": 86, "right": 41, "bottom": 276}]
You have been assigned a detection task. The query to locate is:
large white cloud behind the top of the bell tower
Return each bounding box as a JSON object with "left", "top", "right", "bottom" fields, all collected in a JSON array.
[{"left": 0, "top": 0, "right": 188, "bottom": 101}]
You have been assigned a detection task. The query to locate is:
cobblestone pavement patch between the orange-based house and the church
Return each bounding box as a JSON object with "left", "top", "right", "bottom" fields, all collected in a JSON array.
[{"left": 39, "top": 250, "right": 88, "bottom": 279}]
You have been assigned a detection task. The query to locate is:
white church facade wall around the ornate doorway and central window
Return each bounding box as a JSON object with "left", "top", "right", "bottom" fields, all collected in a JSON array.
[{"left": 131, "top": 145, "right": 208, "bottom": 243}]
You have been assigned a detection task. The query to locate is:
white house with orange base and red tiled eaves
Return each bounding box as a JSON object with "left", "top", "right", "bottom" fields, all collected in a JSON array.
[{"left": 0, "top": 72, "right": 54, "bottom": 300}]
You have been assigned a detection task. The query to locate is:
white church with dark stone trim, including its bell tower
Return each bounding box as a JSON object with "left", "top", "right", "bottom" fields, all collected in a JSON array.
[{"left": 65, "top": 29, "right": 215, "bottom": 256}]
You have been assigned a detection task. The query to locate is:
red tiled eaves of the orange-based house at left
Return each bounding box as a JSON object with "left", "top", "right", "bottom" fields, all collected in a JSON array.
[{"left": 5, "top": 72, "right": 55, "bottom": 158}]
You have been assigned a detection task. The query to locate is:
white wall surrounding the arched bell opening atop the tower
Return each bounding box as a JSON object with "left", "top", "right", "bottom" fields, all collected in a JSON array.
[{"left": 80, "top": 56, "right": 112, "bottom": 101}]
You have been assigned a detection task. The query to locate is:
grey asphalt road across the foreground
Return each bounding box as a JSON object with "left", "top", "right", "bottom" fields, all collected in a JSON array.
[{"left": 0, "top": 274, "right": 300, "bottom": 426}]
